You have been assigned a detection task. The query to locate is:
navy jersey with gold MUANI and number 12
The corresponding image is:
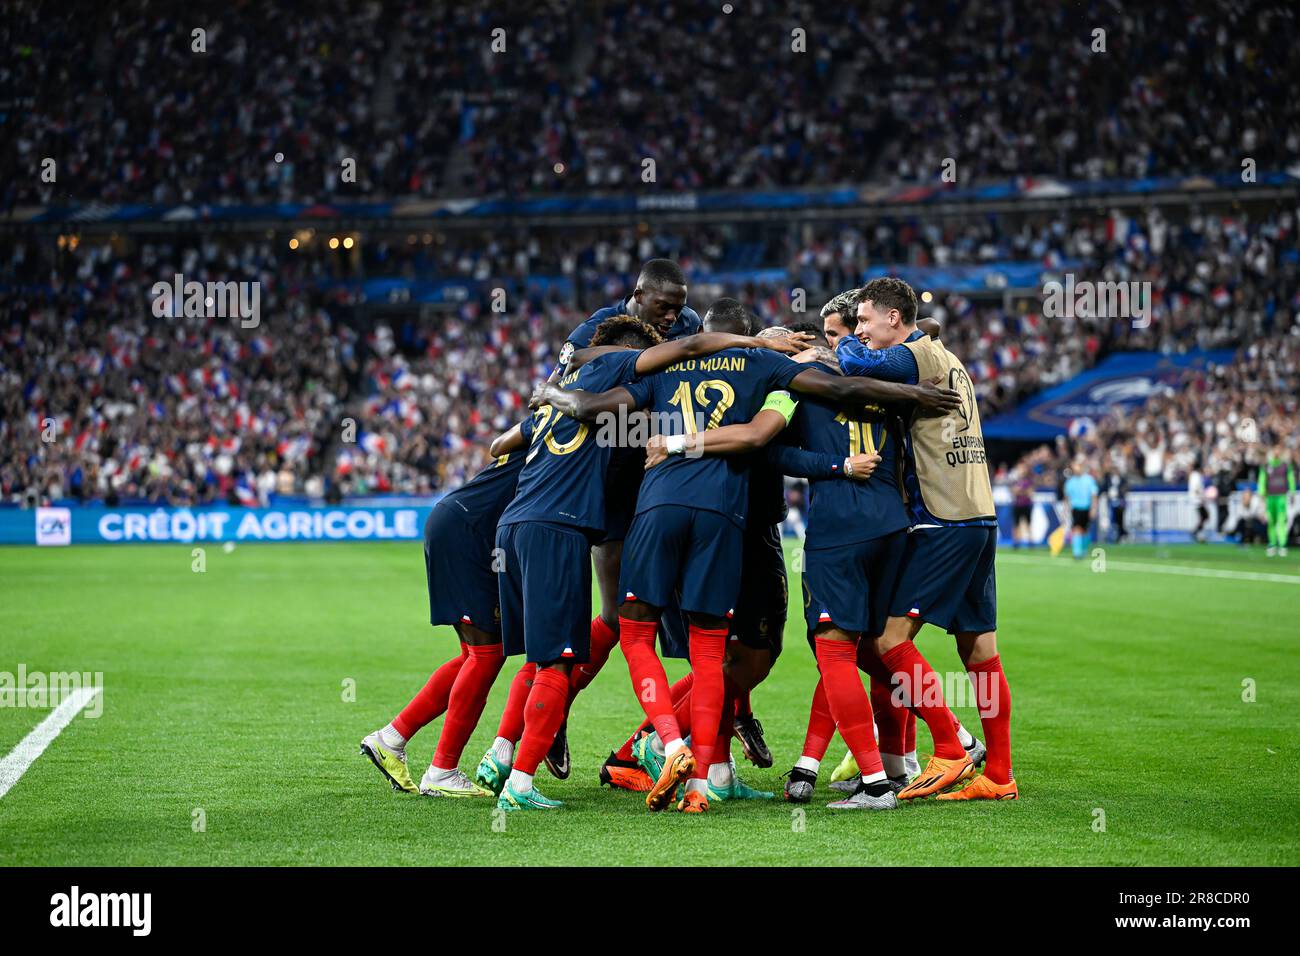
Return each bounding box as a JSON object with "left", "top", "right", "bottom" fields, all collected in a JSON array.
[{"left": 632, "top": 349, "right": 806, "bottom": 528}]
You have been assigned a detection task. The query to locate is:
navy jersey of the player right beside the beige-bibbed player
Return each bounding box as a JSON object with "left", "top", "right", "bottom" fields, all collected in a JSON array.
[{"left": 790, "top": 363, "right": 909, "bottom": 550}]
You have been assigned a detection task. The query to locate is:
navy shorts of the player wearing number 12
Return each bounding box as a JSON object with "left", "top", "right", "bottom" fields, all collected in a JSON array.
[{"left": 619, "top": 505, "right": 744, "bottom": 618}]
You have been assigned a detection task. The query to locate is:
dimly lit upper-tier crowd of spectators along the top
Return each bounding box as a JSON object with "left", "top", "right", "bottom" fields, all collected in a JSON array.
[{"left": 0, "top": 0, "right": 1300, "bottom": 209}]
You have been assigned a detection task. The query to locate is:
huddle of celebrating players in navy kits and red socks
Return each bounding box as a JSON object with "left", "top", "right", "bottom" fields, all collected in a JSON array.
[{"left": 361, "top": 259, "right": 1018, "bottom": 813}]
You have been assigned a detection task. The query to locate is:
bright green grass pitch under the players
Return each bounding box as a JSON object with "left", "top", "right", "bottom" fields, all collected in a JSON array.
[{"left": 0, "top": 544, "right": 1300, "bottom": 866}]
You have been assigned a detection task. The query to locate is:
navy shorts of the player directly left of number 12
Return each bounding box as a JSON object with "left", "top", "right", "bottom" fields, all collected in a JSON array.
[{"left": 497, "top": 522, "right": 592, "bottom": 663}]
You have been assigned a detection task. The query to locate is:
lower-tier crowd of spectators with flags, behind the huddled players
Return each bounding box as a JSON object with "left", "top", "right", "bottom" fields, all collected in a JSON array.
[{"left": 0, "top": 199, "right": 1300, "bottom": 502}]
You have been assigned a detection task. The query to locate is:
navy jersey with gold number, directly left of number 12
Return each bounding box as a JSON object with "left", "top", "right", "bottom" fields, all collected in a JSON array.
[{"left": 501, "top": 349, "right": 641, "bottom": 532}]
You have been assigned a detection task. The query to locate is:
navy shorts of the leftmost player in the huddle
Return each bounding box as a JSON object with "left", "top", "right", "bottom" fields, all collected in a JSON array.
[{"left": 424, "top": 505, "right": 501, "bottom": 633}]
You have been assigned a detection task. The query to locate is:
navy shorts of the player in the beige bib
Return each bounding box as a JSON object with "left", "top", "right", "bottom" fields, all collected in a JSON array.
[{"left": 889, "top": 525, "right": 997, "bottom": 633}]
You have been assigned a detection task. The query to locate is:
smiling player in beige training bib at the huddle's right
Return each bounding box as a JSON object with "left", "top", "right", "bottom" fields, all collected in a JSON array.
[{"left": 836, "top": 277, "right": 1018, "bottom": 800}]
